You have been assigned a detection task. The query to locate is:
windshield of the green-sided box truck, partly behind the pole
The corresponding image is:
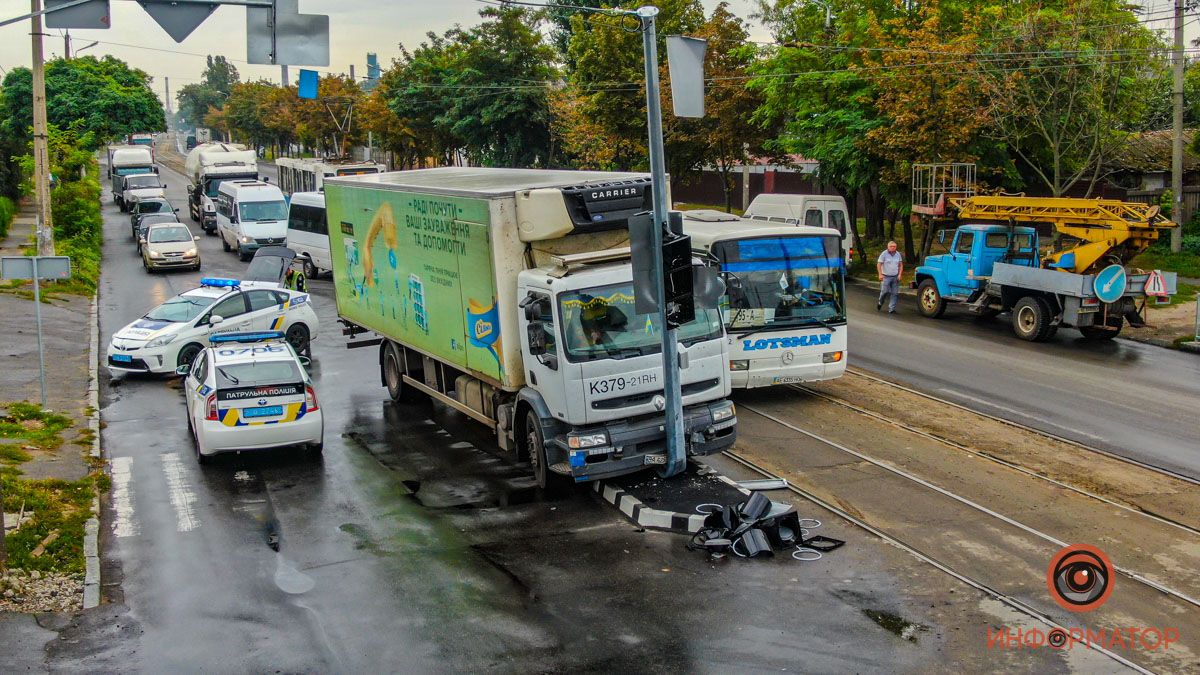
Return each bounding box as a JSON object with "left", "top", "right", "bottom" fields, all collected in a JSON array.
[{"left": 558, "top": 282, "right": 721, "bottom": 362}]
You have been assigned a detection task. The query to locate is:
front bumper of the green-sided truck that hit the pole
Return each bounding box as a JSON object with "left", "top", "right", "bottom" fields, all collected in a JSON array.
[{"left": 550, "top": 400, "right": 737, "bottom": 483}]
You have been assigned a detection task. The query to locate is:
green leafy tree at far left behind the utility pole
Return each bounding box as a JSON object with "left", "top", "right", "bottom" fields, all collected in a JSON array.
[{"left": 0, "top": 56, "right": 167, "bottom": 149}]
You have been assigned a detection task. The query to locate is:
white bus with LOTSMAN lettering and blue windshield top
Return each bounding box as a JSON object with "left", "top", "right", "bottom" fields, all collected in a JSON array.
[{"left": 683, "top": 210, "right": 847, "bottom": 389}]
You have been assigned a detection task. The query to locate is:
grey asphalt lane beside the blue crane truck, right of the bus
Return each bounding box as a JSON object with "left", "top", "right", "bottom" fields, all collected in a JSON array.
[{"left": 850, "top": 283, "right": 1200, "bottom": 478}]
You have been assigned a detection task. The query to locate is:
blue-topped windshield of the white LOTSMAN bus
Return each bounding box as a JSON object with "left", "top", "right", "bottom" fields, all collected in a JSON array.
[{"left": 712, "top": 235, "right": 846, "bottom": 333}]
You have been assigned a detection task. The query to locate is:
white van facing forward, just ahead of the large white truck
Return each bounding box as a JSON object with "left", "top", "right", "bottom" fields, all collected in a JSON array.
[{"left": 215, "top": 179, "right": 288, "bottom": 261}]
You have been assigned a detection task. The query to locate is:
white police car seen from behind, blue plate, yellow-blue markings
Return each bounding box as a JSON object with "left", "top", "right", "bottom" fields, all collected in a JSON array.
[{"left": 176, "top": 330, "right": 325, "bottom": 464}]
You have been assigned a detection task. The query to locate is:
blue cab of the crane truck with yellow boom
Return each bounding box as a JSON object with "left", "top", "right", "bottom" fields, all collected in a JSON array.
[{"left": 914, "top": 223, "right": 1038, "bottom": 300}]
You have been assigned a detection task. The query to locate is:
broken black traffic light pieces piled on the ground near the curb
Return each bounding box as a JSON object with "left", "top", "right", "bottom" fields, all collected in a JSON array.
[{"left": 688, "top": 492, "right": 846, "bottom": 561}]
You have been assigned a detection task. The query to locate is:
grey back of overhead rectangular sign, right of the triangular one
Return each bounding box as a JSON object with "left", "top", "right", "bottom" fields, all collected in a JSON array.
[{"left": 246, "top": 0, "right": 329, "bottom": 66}]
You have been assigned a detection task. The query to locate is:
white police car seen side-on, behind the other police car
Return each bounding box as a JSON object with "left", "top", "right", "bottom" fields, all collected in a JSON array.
[{"left": 107, "top": 279, "right": 318, "bottom": 376}]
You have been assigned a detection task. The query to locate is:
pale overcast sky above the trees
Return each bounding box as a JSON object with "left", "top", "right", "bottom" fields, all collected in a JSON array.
[{"left": 0, "top": 0, "right": 1198, "bottom": 107}]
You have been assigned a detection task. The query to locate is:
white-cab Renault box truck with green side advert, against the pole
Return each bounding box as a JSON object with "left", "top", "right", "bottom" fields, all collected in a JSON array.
[{"left": 325, "top": 167, "right": 737, "bottom": 489}]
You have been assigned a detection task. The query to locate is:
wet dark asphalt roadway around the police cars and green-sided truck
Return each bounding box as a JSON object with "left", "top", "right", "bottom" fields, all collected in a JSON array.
[{"left": 44, "top": 157, "right": 940, "bottom": 673}]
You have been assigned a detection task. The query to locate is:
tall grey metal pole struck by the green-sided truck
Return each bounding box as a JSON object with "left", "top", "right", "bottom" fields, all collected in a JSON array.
[{"left": 636, "top": 6, "right": 688, "bottom": 477}]
